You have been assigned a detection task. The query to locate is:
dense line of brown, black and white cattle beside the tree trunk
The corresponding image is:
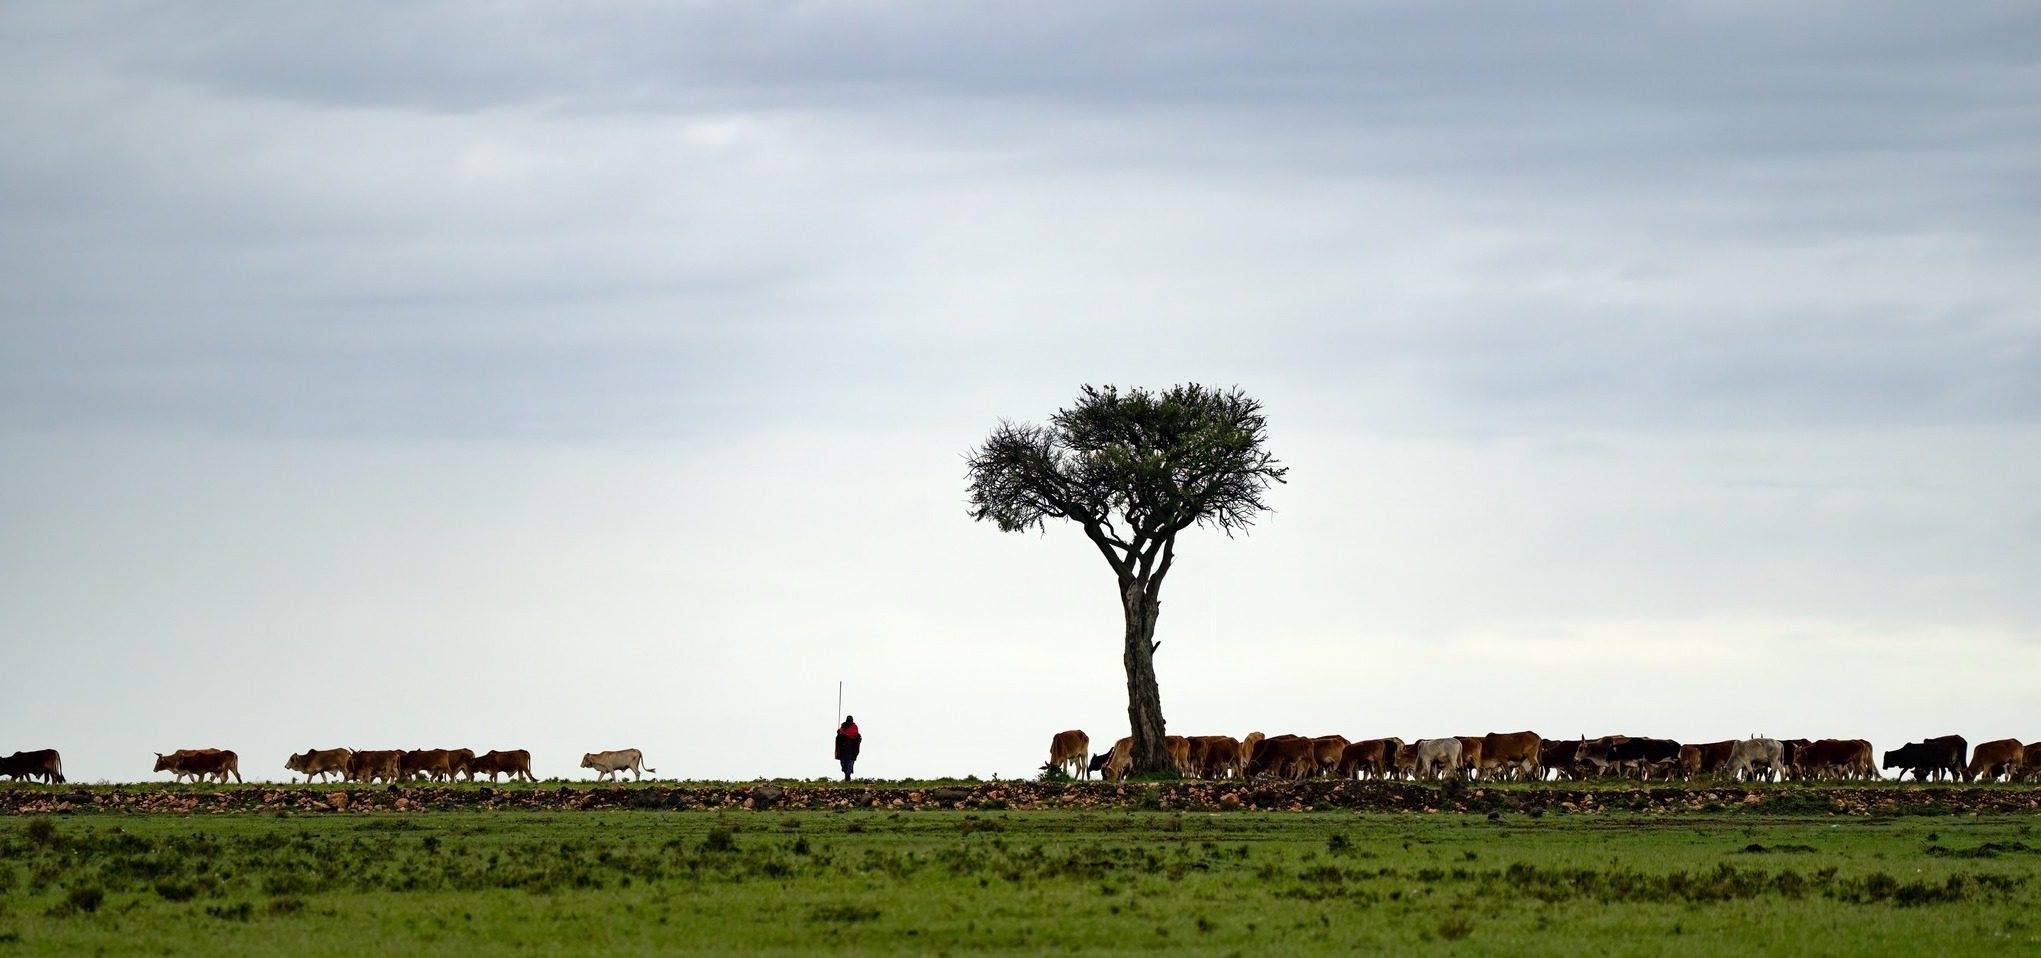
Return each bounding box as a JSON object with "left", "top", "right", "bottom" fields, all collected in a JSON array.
[{"left": 1043, "top": 729, "right": 2041, "bottom": 782}]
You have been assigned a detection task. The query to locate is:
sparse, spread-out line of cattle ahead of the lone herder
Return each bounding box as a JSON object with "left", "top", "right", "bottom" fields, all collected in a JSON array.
[{"left": 0, "top": 748, "right": 657, "bottom": 784}]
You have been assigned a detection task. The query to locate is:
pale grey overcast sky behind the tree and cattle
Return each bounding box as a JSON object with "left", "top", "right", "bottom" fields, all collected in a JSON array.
[{"left": 0, "top": 0, "right": 2041, "bottom": 780}]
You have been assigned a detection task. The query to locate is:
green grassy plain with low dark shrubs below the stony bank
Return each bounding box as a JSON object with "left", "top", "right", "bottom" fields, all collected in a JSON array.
[{"left": 0, "top": 809, "right": 2041, "bottom": 958}]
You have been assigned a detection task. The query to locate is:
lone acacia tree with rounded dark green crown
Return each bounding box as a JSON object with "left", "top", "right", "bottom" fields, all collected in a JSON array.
[{"left": 969, "top": 384, "right": 1290, "bottom": 772}]
